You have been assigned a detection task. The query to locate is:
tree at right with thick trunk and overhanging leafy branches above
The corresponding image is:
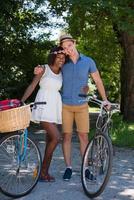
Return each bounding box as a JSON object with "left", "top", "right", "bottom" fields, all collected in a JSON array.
[{"left": 49, "top": 0, "right": 134, "bottom": 121}]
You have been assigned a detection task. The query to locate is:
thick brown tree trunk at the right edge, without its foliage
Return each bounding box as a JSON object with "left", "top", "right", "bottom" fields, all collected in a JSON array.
[{"left": 120, "top": 33, "right": 134, "bottom": 122}]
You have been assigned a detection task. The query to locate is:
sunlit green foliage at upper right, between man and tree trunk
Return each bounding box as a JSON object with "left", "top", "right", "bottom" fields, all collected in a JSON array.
[{"left": 49, "top": 0, "right": 134, "bottom": 101}]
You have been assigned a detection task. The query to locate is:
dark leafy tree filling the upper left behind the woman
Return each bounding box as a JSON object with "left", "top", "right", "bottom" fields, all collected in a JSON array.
[{"left": 0, "top": 0, "right": 53, "bottom": 98}]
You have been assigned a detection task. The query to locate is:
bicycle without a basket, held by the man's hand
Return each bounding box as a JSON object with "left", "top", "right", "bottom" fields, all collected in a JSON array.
[{"left": 81, "top": 96, "right": 119, "bottom": 198}]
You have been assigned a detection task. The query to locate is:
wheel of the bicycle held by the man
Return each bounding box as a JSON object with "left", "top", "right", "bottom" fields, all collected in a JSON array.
[{"left": 81, "top": 134, "right": 113, "bottom": 198}]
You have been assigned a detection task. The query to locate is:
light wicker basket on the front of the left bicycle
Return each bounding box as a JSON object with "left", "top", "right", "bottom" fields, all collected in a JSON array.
[{"left": 0, "top": 105, "right": 31, "bottom": 133}]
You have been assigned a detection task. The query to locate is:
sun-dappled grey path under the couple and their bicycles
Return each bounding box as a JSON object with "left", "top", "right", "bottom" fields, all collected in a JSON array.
[{"left": 0, "top": 129, "right": 134, "bottom": 200}]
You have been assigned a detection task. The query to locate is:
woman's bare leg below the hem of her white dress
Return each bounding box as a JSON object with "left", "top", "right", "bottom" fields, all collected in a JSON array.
[{"left": 41, "top": 122, "right": 60, "bottom": 177}]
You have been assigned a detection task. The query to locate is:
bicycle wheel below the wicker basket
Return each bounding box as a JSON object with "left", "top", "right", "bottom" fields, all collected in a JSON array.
[{"left": 0, "top": 133, "right": 41, "bottom": 198}]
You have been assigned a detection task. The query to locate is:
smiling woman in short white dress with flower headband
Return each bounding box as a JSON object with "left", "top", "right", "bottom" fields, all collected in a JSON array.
[{"left": 21, "top": 47, "right": 65, "bottom": 182}]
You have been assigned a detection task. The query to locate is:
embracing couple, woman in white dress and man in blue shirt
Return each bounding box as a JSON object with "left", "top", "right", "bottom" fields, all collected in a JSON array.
[{"left": 21, "top": 34, "right": 110, "bottom": 182}]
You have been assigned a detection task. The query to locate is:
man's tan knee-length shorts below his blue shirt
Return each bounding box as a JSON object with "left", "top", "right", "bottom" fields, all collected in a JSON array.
[{"left": 62, "top": 103, "right": 89, "bottom": 133}]
